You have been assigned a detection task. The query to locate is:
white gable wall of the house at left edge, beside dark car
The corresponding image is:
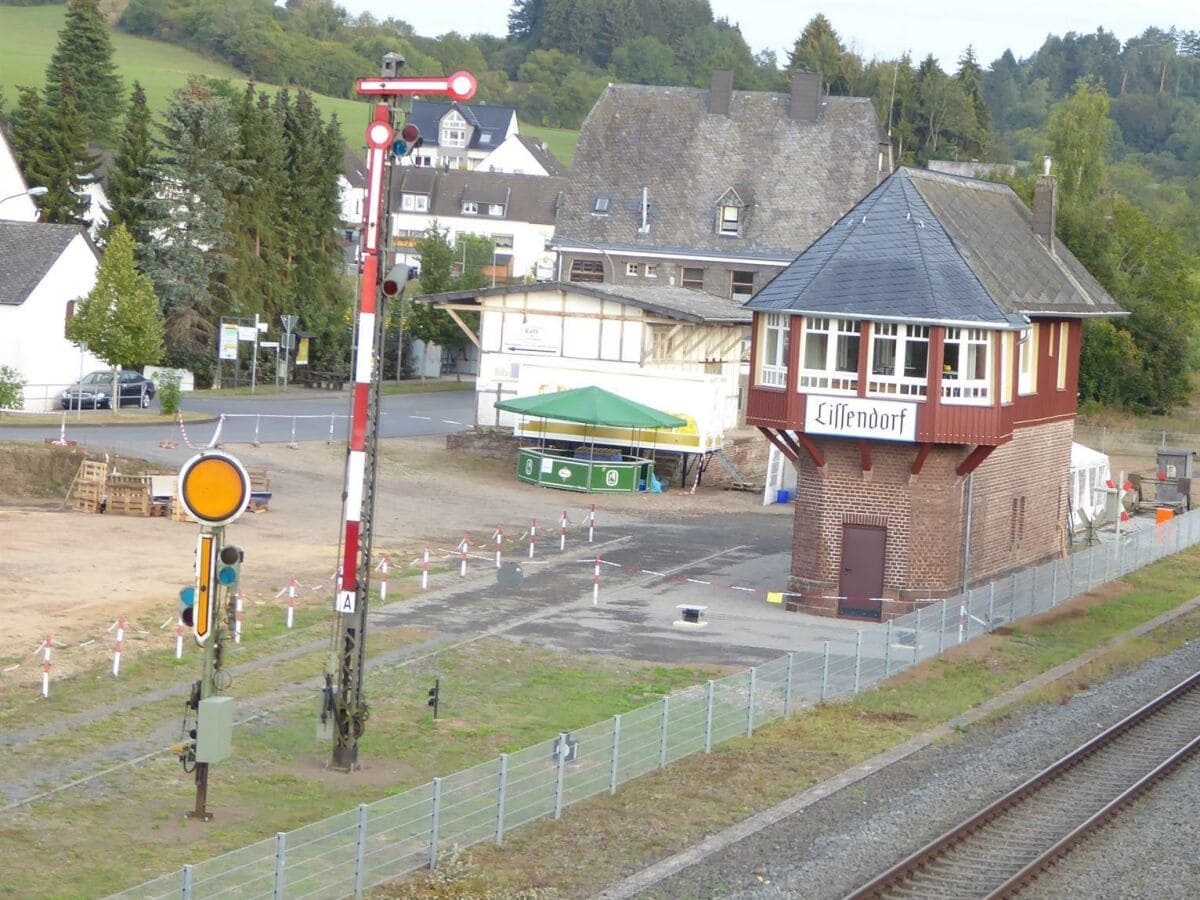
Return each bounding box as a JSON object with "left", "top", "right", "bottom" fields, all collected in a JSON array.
[{"left": 0, "top": 235, "right": 108, "bottom": 410}]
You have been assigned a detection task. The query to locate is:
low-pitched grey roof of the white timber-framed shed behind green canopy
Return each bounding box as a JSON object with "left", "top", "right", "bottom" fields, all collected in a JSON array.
[{"left": 418, "top": 282, "right": 750, "bottom": 325}]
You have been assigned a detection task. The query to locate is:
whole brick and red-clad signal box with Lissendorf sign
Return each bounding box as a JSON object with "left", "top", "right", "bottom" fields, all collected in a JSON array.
[{"left": 746, "top": 160, "right": 1123, "bottom": 617}]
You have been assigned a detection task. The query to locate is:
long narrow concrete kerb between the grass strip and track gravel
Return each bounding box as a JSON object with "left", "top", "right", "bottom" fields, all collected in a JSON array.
[{"left": 594, "top": 595, "right": 1200, "bottom": 900}]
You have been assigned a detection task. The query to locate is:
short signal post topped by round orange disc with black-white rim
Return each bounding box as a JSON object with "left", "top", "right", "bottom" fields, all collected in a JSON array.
[{"left": 179, "top": 451, "right": 250, "bottom": 821}]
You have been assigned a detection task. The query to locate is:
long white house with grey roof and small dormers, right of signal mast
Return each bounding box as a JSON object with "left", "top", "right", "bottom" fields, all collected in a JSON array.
[{"left": 391, "top": 166, "right": 565, "bottom": 283}]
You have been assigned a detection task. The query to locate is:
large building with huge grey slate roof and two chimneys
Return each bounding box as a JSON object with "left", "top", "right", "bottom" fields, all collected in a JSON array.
[{"left": 553, "top": 70, "right": 892, "bottom": 299}]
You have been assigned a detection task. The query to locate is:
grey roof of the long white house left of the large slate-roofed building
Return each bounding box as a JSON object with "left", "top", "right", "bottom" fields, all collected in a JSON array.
[{"left": 391, "top": 166, "right": 566, "bottom": 224}]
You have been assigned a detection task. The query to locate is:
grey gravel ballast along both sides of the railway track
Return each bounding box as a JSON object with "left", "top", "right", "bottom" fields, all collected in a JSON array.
[{"left": 641, "top": 641, "right": 1200, "bottom": 900}]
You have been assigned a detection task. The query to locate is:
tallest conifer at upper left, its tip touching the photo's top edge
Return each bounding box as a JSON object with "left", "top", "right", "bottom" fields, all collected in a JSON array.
[{"left": 46, "top": 0, "right": 125, "bottom": 144}]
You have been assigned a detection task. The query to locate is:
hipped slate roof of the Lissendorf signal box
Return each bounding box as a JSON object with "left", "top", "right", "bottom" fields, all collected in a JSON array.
[{"left": 746, "top": 168, "right": 1122, "bottom": 326}]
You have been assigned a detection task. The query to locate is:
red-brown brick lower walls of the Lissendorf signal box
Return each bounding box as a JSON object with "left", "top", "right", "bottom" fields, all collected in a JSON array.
[{"left": 790, "top": 421, "right": 1073, "bottom": 611}]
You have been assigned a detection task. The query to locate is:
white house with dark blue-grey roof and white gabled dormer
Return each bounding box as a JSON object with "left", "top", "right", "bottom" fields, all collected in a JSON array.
[{"left": 404, "top": 100, "right": 517, "bottom": 169}]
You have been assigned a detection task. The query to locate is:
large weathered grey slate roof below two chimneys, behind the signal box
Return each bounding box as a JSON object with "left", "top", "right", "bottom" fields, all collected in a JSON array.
[{"left": 556, "top": 84, "right": 887, "bottom": 260}]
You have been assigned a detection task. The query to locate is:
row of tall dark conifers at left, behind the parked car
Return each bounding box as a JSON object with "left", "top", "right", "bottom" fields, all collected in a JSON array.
[{"left": 7, "top": 0, "right": 353, "bottom": 384}]
